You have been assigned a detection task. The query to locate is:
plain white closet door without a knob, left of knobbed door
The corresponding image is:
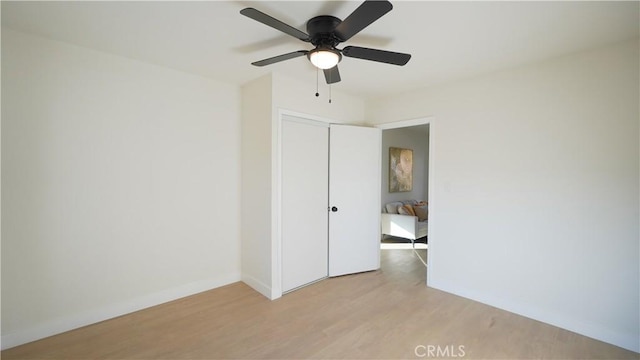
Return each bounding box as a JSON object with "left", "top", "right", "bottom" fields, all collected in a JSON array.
[{"left": 282, "top": 116, "right": 329, "bottom": 292}]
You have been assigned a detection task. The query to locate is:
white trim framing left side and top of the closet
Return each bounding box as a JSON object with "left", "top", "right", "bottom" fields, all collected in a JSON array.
[{"left": 270, "top": 108, "right": 342, "bottom": 300}]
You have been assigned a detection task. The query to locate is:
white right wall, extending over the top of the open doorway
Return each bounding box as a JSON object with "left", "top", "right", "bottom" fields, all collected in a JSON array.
[{"left": 367, "top": 39, "right": 640, "bottom": 351}]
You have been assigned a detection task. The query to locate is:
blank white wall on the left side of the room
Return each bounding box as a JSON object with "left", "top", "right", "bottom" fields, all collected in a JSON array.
[{"left": 2, "top": 30, "right": 240, "bottom": 348}]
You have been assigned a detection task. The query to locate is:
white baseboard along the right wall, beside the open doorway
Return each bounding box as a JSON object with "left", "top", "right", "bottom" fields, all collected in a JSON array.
[{"left": 429, "top": 279, "right": 640, "bottom": 352}]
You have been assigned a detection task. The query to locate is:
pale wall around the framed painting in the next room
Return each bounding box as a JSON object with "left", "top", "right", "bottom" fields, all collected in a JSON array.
[{"left": 381, "top": 125, "right": 429, "bottom": 205}]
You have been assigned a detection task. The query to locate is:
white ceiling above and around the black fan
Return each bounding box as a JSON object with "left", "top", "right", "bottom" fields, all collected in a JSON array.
[{"left": 2, "top": 0, "right": 640, "bottom": 97}]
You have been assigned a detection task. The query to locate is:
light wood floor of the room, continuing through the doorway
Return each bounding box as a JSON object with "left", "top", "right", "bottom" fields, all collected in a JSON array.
[{"left": 1, "top": 250, "right": 639, "bottom": 360}]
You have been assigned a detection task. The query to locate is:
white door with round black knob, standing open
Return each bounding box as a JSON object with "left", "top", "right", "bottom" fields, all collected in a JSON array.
[{"left": 329, "top": 125, "right": 382, "bottom": 276}]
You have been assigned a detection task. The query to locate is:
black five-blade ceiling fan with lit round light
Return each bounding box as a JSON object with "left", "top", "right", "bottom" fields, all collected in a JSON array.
[{"left": 240, "top": 0, "right": 411, "bottom": 84}]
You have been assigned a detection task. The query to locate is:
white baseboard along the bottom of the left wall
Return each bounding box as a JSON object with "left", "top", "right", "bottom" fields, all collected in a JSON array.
[{"left": 0, "top": 273, "right": 241, "bottom": 350}]
